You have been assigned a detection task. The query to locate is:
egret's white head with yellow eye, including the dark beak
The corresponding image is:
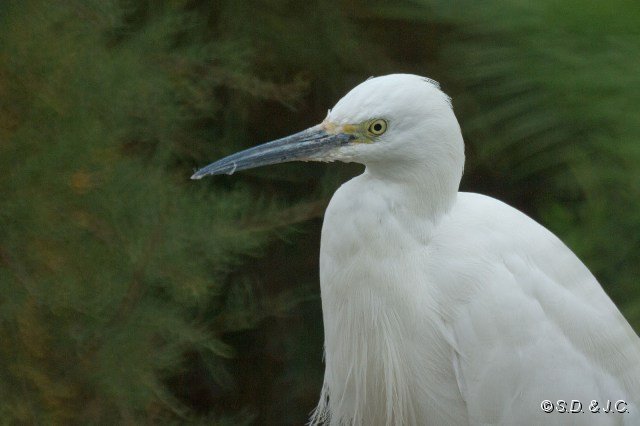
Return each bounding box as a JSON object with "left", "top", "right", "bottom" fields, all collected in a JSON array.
[{"left": 191, "top": 74, "right": 464, "bottom": 185}]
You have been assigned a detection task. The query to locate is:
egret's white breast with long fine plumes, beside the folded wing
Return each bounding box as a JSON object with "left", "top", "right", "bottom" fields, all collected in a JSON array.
[{"left": 319, "top": 176, "right": 466, "bottom": 425}]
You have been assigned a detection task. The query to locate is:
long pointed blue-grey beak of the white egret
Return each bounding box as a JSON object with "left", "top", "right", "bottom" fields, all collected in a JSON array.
[{"left": 191, "top": 125, "right": 355, "bottom": 179}]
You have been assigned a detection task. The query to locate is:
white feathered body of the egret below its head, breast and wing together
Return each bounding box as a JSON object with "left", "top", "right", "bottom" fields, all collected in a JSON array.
[{"left": 318, "top": 181, "right": 640, "bottom": 425}]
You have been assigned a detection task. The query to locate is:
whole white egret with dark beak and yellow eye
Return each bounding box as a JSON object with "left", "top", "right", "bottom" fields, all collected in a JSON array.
[{"left": 192, "top": 74, "right": 640, "bottom": 425}]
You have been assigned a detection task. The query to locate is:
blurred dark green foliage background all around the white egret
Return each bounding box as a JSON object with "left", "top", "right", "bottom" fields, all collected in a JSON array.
[{"left": 0, "top": 0, "right": 640, "bottom": 424}]
